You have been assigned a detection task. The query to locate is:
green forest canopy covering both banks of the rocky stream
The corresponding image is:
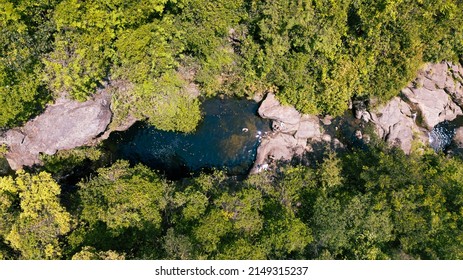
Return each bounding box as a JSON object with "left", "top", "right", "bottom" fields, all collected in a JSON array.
[{"left": 0, "top": 0, "right": 463, "bottom": 259}]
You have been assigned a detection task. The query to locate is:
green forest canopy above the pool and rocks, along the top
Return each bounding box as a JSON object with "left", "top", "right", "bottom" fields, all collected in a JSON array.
[{"left": 0, "top": 0, "right": 463, "bottom": 131}]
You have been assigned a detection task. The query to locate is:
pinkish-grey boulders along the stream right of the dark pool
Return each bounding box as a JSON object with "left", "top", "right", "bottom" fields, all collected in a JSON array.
[{"left": 256, "top": 62, "right": 463, "bottom": 174}]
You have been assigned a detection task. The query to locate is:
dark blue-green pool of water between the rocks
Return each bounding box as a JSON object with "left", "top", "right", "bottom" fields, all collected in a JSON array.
[{"left": 106, "top": 98, "right": 270, "bottom": 178}]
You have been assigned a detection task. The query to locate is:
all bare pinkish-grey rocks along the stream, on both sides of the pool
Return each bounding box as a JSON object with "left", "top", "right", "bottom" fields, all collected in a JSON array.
[{"left": 0, "top": 62, "right": 463, "bottom": 174}]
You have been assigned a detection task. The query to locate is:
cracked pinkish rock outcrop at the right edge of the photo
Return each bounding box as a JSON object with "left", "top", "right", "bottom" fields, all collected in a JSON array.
[{"left": 368, "top": 62, "right": 463, "bottom": 153}]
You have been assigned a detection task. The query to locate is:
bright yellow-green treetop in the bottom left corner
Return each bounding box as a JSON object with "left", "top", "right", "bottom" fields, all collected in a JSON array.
[{"left": 0, "top": 171, "right": 71, "bottom": 259}]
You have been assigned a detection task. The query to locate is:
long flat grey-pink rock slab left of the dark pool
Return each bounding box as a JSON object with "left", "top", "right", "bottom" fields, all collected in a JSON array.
[{"left": 0, "top": 94, "right": 112, "bottom": 170}]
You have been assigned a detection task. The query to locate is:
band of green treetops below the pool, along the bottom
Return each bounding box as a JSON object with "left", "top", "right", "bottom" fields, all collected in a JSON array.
[{"left": 0, "top": 142, "right": 463, "bottom": 259}]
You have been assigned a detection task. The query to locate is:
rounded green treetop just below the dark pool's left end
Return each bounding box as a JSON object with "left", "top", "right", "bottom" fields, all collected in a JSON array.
[{"left": 80, "top": 161, "right": 167, "bottom": 233}]
